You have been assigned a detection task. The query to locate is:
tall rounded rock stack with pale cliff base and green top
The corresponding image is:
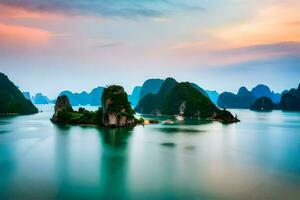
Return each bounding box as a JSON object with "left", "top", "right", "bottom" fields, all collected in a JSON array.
[{"left": 102, "top": 85, "right": 136, "bottom": 127}]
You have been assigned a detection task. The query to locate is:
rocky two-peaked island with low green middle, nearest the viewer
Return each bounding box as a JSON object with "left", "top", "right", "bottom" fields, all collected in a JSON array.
[{"left": 51, "top": 85, "right": 144, "bottom": 127}]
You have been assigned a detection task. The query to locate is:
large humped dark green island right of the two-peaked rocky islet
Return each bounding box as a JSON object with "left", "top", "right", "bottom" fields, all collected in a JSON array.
[{"left": 135, "top": 78, "right": 239, "bottom": 123}]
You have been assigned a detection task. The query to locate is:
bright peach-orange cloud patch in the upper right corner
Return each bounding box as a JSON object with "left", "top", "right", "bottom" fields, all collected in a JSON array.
[{"left": 211, "top": 4, "right": 300, "bottom": 48}]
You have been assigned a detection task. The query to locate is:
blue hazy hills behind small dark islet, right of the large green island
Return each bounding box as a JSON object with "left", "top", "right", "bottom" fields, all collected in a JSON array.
[{"left": 217, "top": 84, "right": 282, "bottom": 109}]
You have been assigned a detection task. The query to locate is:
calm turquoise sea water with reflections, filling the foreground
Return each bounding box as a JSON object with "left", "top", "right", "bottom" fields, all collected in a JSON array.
[{"left": 0, "top": 106, "right": 300, "bottom": 200}]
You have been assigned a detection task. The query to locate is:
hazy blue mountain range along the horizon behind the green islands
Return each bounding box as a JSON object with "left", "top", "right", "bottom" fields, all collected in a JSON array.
[{"left": 18, "top": 75, "right": 299, "bottom": 110}]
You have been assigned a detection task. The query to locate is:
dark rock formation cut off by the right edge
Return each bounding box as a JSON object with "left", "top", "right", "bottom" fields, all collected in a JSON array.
[{"left": 279, "top": 84, "right": 300, "bottom": 111}]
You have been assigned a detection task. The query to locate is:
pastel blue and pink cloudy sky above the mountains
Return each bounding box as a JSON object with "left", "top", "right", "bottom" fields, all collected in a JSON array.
[{"left": 0, "top": 0, "right": 300, "bottom": 98}]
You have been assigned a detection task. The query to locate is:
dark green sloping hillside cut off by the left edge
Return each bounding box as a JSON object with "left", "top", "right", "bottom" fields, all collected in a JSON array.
[{"left": 0, "top": 73, "right": 38, "bottom": 115}]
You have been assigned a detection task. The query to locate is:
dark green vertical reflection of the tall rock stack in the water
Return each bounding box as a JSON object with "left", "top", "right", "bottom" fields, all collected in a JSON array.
[{"left": 99, "top": 128, "right": 133, "bottom": 199}]
